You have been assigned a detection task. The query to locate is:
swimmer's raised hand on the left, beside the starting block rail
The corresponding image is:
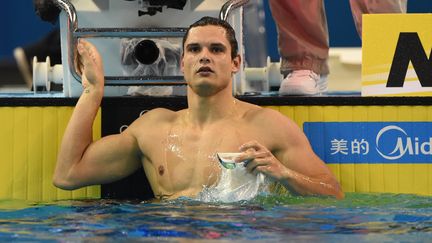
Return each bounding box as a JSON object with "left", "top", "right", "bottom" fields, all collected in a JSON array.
[{"left": 76, "top": 39, "right": 104, "bottom": 92}]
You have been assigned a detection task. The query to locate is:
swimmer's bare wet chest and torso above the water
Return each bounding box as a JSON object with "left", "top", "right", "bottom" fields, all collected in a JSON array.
[{"left": 129, "top": 101, "right": 272, "bottom": 199}]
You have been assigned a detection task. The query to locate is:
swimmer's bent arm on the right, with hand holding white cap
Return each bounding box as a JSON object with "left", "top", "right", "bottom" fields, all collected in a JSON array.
[{"left": 236, "top": 109, "right": 344, "bottom": 199}]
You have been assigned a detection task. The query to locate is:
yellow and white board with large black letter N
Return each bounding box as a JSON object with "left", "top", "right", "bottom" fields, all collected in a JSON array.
[{"left": 362, "top": 14, "right": 432, "bottom": 96}]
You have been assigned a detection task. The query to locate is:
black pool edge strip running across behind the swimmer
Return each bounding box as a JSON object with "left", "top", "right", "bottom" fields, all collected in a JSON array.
[{"left": 0, "top": 92, "right": 432, "bottom": 107}]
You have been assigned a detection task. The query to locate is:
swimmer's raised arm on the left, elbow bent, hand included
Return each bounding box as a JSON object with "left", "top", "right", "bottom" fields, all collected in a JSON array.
[{"left": 53, "top": 40, "right": 140, "bottom": 189}]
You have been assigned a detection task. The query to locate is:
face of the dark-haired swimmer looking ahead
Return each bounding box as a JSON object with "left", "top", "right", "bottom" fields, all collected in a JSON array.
[{"left": 181, "top": 25, "right": 240, "bottom": 96}]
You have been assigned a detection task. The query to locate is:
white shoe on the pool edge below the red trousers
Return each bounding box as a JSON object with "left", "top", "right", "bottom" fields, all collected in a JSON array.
[{"left": 279, "top": 70, "right": 327, "bottom": 95}]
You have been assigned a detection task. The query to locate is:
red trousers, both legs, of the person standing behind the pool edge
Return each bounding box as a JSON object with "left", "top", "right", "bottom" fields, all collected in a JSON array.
[{"left": 269, "top": 0, "right": 407, "bottom": 74}]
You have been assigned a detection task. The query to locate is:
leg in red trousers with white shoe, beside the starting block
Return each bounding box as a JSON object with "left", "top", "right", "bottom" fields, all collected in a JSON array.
[{"left": 269, "top": 0, "right": 329, "bottom": 95}]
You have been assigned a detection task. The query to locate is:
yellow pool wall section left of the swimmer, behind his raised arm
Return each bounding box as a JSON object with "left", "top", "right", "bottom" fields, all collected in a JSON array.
[{"left": 0, "top": 106, "right": 101, "bottom": 202}]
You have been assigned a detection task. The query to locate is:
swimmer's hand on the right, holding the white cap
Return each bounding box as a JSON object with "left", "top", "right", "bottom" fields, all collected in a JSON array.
[{"left": 235, "top": 141, "right": 287, "bottom": 180}]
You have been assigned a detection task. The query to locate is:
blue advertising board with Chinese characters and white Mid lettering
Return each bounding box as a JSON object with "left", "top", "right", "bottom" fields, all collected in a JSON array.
[{"left": 303, "top": 122, "right": 432, "bottom": 163}]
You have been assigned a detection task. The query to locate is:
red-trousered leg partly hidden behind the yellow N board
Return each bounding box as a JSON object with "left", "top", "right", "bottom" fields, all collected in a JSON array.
[{"left": 350, "top": 0, "right": 408, "bottom": 38}]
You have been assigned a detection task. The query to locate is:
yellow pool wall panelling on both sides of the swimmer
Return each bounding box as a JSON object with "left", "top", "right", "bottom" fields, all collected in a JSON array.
[{"left": 0, "top": 100, "right": 432, "bottom": 201}]
